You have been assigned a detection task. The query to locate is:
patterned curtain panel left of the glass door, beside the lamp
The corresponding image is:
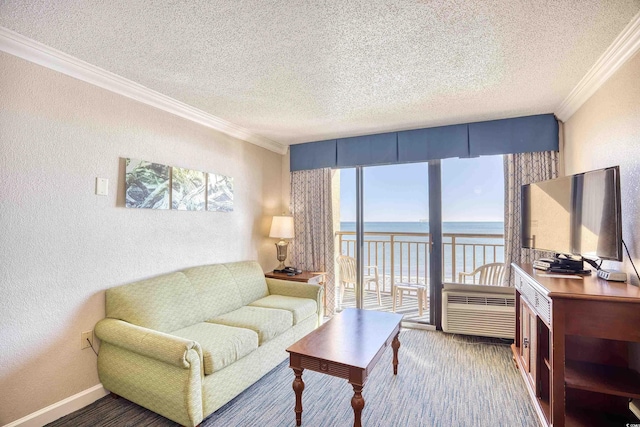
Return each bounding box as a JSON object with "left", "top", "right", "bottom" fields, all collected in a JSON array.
[{"left": 291, "top": 168, "right": 335, "bottom": 315}]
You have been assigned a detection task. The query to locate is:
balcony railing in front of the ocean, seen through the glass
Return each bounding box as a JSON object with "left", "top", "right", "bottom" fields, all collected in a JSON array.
[{"left": 336, "top": 231, "right": 504, "bottom": 292}]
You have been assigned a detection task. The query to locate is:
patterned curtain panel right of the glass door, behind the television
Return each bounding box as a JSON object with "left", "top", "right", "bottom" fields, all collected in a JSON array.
[{"left": 504, "top": 151, "right": 558, "bottom": 286}]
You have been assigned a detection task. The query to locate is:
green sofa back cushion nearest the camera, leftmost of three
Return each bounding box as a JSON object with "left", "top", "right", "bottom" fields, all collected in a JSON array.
[{"left": 106, "top": 272, "right": 203, "bottom": 332}]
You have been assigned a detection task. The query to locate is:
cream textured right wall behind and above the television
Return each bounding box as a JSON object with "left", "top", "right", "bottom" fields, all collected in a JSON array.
[{"left": 564, "top": 53, "right": 640, "bottom": 285}]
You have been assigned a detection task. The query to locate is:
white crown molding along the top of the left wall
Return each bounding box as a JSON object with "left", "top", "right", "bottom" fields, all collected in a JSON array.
[{"left": 0, "top": 27, "right": 288, "bottom": 154}]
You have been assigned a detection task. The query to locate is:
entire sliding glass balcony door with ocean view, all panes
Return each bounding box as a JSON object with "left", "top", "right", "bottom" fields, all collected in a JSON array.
[{"left": 336, "top": 156, "right": 504, "bottom": 326}]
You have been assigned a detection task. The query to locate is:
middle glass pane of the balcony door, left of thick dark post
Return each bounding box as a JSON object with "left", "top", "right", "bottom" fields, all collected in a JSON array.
[{"left": 362, "top": 163, "right": 430, "bottom": 323}]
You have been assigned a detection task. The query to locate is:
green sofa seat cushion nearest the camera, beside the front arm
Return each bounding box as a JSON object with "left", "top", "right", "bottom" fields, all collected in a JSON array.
[{"left": 171, "top": 322, "right": 258, "bottom": 375}]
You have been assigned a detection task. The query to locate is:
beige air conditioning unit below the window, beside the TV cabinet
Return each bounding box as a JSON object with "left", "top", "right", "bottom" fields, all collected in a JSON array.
[{"left": 442, "top": 284, "right": 516, "bottom": 339}]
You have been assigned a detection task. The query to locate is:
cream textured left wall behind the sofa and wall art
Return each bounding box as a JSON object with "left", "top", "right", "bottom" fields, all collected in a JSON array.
[{"left": 0, "top": 53, "right": 283, "bottom": 425}]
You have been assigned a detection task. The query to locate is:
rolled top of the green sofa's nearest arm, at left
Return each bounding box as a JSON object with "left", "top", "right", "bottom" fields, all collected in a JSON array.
[{"left": 95, "top": 318, "right": 202, "bottom": 369}]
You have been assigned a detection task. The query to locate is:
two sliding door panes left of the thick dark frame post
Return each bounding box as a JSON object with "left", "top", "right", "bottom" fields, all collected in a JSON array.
[{"left": 335, "top": 163, "right": 433, "bottom": 323}]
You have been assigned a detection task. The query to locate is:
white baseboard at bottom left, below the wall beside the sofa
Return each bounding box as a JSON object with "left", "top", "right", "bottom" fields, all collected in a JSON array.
[{"left": 3, "top": 384, "right": 109, "bottom": 427}]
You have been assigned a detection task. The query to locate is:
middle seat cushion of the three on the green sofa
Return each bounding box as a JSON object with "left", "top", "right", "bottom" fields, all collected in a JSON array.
[{"left": 207, "top": 306, "right": 293, "bottom": 345}]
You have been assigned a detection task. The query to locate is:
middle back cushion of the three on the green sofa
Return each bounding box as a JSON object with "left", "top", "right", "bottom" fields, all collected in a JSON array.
[{"left": 182, "top": 264, "right": 242, "bottom": 321}]
